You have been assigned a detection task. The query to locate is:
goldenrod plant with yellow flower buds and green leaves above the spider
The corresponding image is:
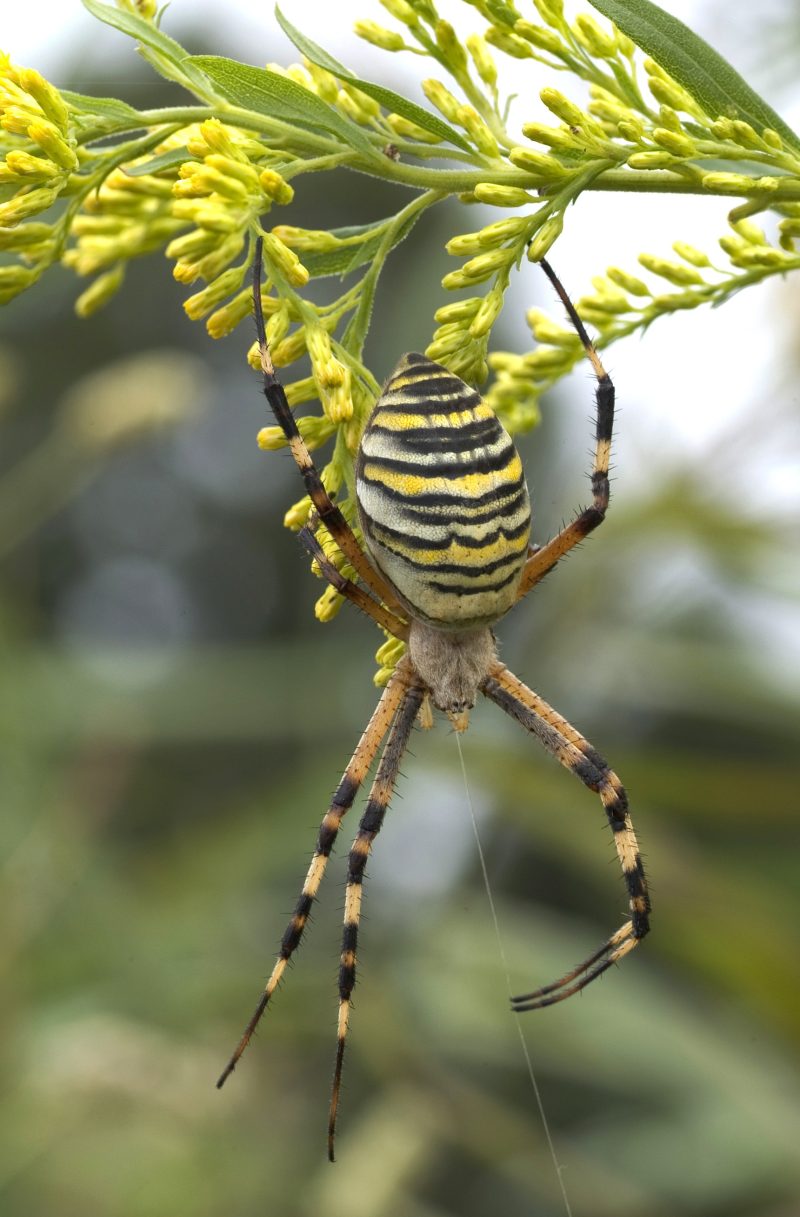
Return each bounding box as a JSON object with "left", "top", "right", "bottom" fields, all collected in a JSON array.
[{"left": 0, "top": 0, "right": 800, "bottom": 667}]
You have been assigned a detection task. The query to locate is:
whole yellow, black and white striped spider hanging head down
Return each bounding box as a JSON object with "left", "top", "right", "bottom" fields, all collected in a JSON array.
[{"left": 217, "top": 240, "right": 650, "bottom": 1162}]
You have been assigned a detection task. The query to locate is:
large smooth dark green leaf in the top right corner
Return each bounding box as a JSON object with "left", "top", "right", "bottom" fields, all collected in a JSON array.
[{"left": 592, "top": 0, "right": 800, "bottom": 150}]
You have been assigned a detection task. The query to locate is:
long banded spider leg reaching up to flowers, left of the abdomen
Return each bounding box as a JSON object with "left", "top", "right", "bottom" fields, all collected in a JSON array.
[{"left": 253, "top": 237, "right": 399, "bottom": 618}]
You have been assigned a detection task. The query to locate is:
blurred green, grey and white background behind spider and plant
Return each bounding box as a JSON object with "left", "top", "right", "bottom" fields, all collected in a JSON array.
[{"left": 0, "top": 0, "right": 800, "bottom": 1217}]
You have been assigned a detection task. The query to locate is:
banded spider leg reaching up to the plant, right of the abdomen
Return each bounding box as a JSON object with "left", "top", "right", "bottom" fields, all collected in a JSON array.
[{"left": 516, "top": 258, "right": 614, "bottom": 600}]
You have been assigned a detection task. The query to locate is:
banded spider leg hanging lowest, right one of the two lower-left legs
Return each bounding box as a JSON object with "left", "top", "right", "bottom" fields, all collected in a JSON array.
[{"left": 328, "top": 683, "right": 425, "bottom": 1162}]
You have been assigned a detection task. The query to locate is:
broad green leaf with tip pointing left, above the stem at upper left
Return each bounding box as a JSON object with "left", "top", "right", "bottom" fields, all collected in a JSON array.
[{"left": 184, "top": 55, "right": 377, "bottom": 161}]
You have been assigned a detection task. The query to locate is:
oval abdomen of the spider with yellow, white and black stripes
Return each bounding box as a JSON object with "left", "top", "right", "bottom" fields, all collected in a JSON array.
[{"left": 356, "top": 354, "right": 531, "bottom": 629}]
